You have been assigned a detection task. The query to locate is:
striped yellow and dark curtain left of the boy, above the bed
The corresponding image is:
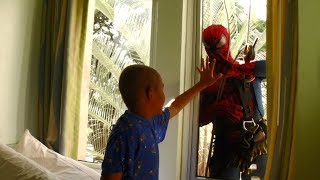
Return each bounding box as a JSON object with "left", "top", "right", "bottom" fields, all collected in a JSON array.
[{"left": 38, "top": 0, "right": 88, "bottom": 158}]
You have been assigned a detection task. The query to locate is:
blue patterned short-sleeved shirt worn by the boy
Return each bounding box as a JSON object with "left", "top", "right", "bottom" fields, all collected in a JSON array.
[{"left": 101, "top": 108, "right": 170, "bottom": 180}]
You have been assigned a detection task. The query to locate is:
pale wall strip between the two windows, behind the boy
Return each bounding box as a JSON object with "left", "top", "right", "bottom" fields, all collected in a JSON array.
[{"left": 150, "top": 0, "right": 182, "bottom": 180}]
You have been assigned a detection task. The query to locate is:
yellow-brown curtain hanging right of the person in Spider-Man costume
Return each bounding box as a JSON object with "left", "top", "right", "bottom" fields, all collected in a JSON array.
[{"left": 265, "top": 0, "right": 298, "bottom": 179}]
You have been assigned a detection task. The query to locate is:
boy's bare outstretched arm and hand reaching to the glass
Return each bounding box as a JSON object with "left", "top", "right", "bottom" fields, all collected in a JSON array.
[{"left": 169, "top": 58, "right": 222, "bottom": 118}]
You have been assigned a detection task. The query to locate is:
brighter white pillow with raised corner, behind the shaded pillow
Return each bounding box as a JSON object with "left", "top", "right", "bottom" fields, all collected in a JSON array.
[{"left": 16, "top": 130, "right": 100, "bottom": 180}]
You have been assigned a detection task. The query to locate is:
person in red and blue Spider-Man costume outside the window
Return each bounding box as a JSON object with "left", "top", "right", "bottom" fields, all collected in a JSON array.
[{"left": 199, "top": 24, "right": 266, "bottom": 179}]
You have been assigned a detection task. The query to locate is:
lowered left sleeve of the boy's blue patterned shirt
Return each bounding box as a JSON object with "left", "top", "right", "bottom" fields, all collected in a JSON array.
[{"left": 101, "top": 123, "right": 140, "bottom": 176}]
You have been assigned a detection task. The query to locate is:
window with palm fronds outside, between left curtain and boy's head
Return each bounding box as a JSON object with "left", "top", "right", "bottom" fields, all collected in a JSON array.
[{"left": 86, "top": 0, "right": 152, "bottom": 162}]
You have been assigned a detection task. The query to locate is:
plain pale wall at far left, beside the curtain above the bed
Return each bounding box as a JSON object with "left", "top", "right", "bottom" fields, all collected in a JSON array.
[{"left": 0, "top": 0, "right": 42, "bottom": 144}]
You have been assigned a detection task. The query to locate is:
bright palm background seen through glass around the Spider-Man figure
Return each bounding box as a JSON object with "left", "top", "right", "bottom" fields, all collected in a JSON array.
[{"left": 197, "top": 0, "right": 267, "bottom": 179}]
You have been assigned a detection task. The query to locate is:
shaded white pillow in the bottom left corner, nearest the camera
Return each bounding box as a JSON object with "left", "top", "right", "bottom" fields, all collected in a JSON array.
[{"left": 0, "top": 142, "right": 56, "bottom": 180}]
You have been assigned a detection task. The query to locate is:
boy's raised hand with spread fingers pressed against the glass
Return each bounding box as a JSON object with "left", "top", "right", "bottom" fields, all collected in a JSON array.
[{"left": 197, "top": 57, "right": 222, "bottom": 86}]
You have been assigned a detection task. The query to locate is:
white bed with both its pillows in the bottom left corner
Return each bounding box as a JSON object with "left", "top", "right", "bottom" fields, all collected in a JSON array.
[{"left": 0, "top": 130, "right": 100, "bottom": 180}]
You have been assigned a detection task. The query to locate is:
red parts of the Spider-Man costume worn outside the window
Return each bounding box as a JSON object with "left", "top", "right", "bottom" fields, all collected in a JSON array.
[{"left": 200, "top": 25, "right": 256, "bottom": 142}]
